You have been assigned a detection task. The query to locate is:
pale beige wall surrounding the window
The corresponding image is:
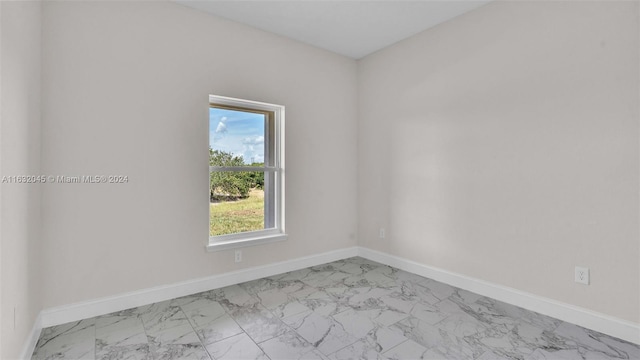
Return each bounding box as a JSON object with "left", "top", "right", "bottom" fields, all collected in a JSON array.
[{"left": 42, "top": 1, "right": 357, "bottom": 308}]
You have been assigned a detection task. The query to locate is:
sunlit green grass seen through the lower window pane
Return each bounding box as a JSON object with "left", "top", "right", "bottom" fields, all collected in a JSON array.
[{"left": 209, "top": 190, "right": 264, "bottom": 236}]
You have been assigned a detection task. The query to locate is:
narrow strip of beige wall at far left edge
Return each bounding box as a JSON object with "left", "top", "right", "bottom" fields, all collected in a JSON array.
[{"left": 0, "top": 1, "right": 42, "bottom": 359}]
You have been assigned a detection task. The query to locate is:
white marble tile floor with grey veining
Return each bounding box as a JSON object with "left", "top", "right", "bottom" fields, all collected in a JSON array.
[{"left": 32, "top": 257, "right": 640, "bottom": 360}]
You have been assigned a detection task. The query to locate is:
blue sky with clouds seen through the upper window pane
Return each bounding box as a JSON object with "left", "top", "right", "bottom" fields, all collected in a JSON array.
[{"left": 209, "top": 108, "right": 264, "bottom": 164}]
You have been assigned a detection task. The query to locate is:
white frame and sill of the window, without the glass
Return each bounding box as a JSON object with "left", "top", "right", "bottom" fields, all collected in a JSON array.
[{"left": 207, "top": 95, "right": 287, "bottom": 251}]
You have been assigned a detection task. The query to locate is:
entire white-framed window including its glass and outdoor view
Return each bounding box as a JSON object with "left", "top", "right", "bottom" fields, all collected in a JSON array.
[{"left": 207, "top": 95, "right": 286, "bottom": 251}]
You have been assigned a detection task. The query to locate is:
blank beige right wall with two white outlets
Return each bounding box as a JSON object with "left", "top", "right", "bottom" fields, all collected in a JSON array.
[{"left": 358, "top": 1, "right": 640, "bottom": 323}]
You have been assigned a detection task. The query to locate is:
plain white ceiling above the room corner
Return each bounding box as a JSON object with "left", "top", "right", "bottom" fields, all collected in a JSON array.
[{"left": 174, "top": 0, "right": 491, "bottom": 59}]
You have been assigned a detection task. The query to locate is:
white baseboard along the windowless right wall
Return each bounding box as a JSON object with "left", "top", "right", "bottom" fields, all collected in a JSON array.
[{"left": 358, "top": 247, "right": 640, "bottom": 345}]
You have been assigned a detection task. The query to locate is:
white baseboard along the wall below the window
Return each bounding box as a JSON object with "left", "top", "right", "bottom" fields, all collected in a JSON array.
[{"left": 36, "top": 247, "right": 358, "bottom": 330}]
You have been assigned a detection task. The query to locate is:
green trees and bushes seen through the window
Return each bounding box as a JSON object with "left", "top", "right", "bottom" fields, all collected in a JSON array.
[{"left": 209, "top": 147, "right": 264, "bottom": 201}]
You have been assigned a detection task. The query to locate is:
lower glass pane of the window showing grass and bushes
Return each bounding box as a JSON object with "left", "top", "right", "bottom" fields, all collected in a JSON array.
[{"left": 209, "top": 171, "right": 265, "bottom": 236}]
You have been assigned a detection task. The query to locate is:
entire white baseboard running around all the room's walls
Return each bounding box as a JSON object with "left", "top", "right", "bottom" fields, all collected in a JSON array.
[{"left": 23, "top": 247, "right": 640, "bottom": 352}]
